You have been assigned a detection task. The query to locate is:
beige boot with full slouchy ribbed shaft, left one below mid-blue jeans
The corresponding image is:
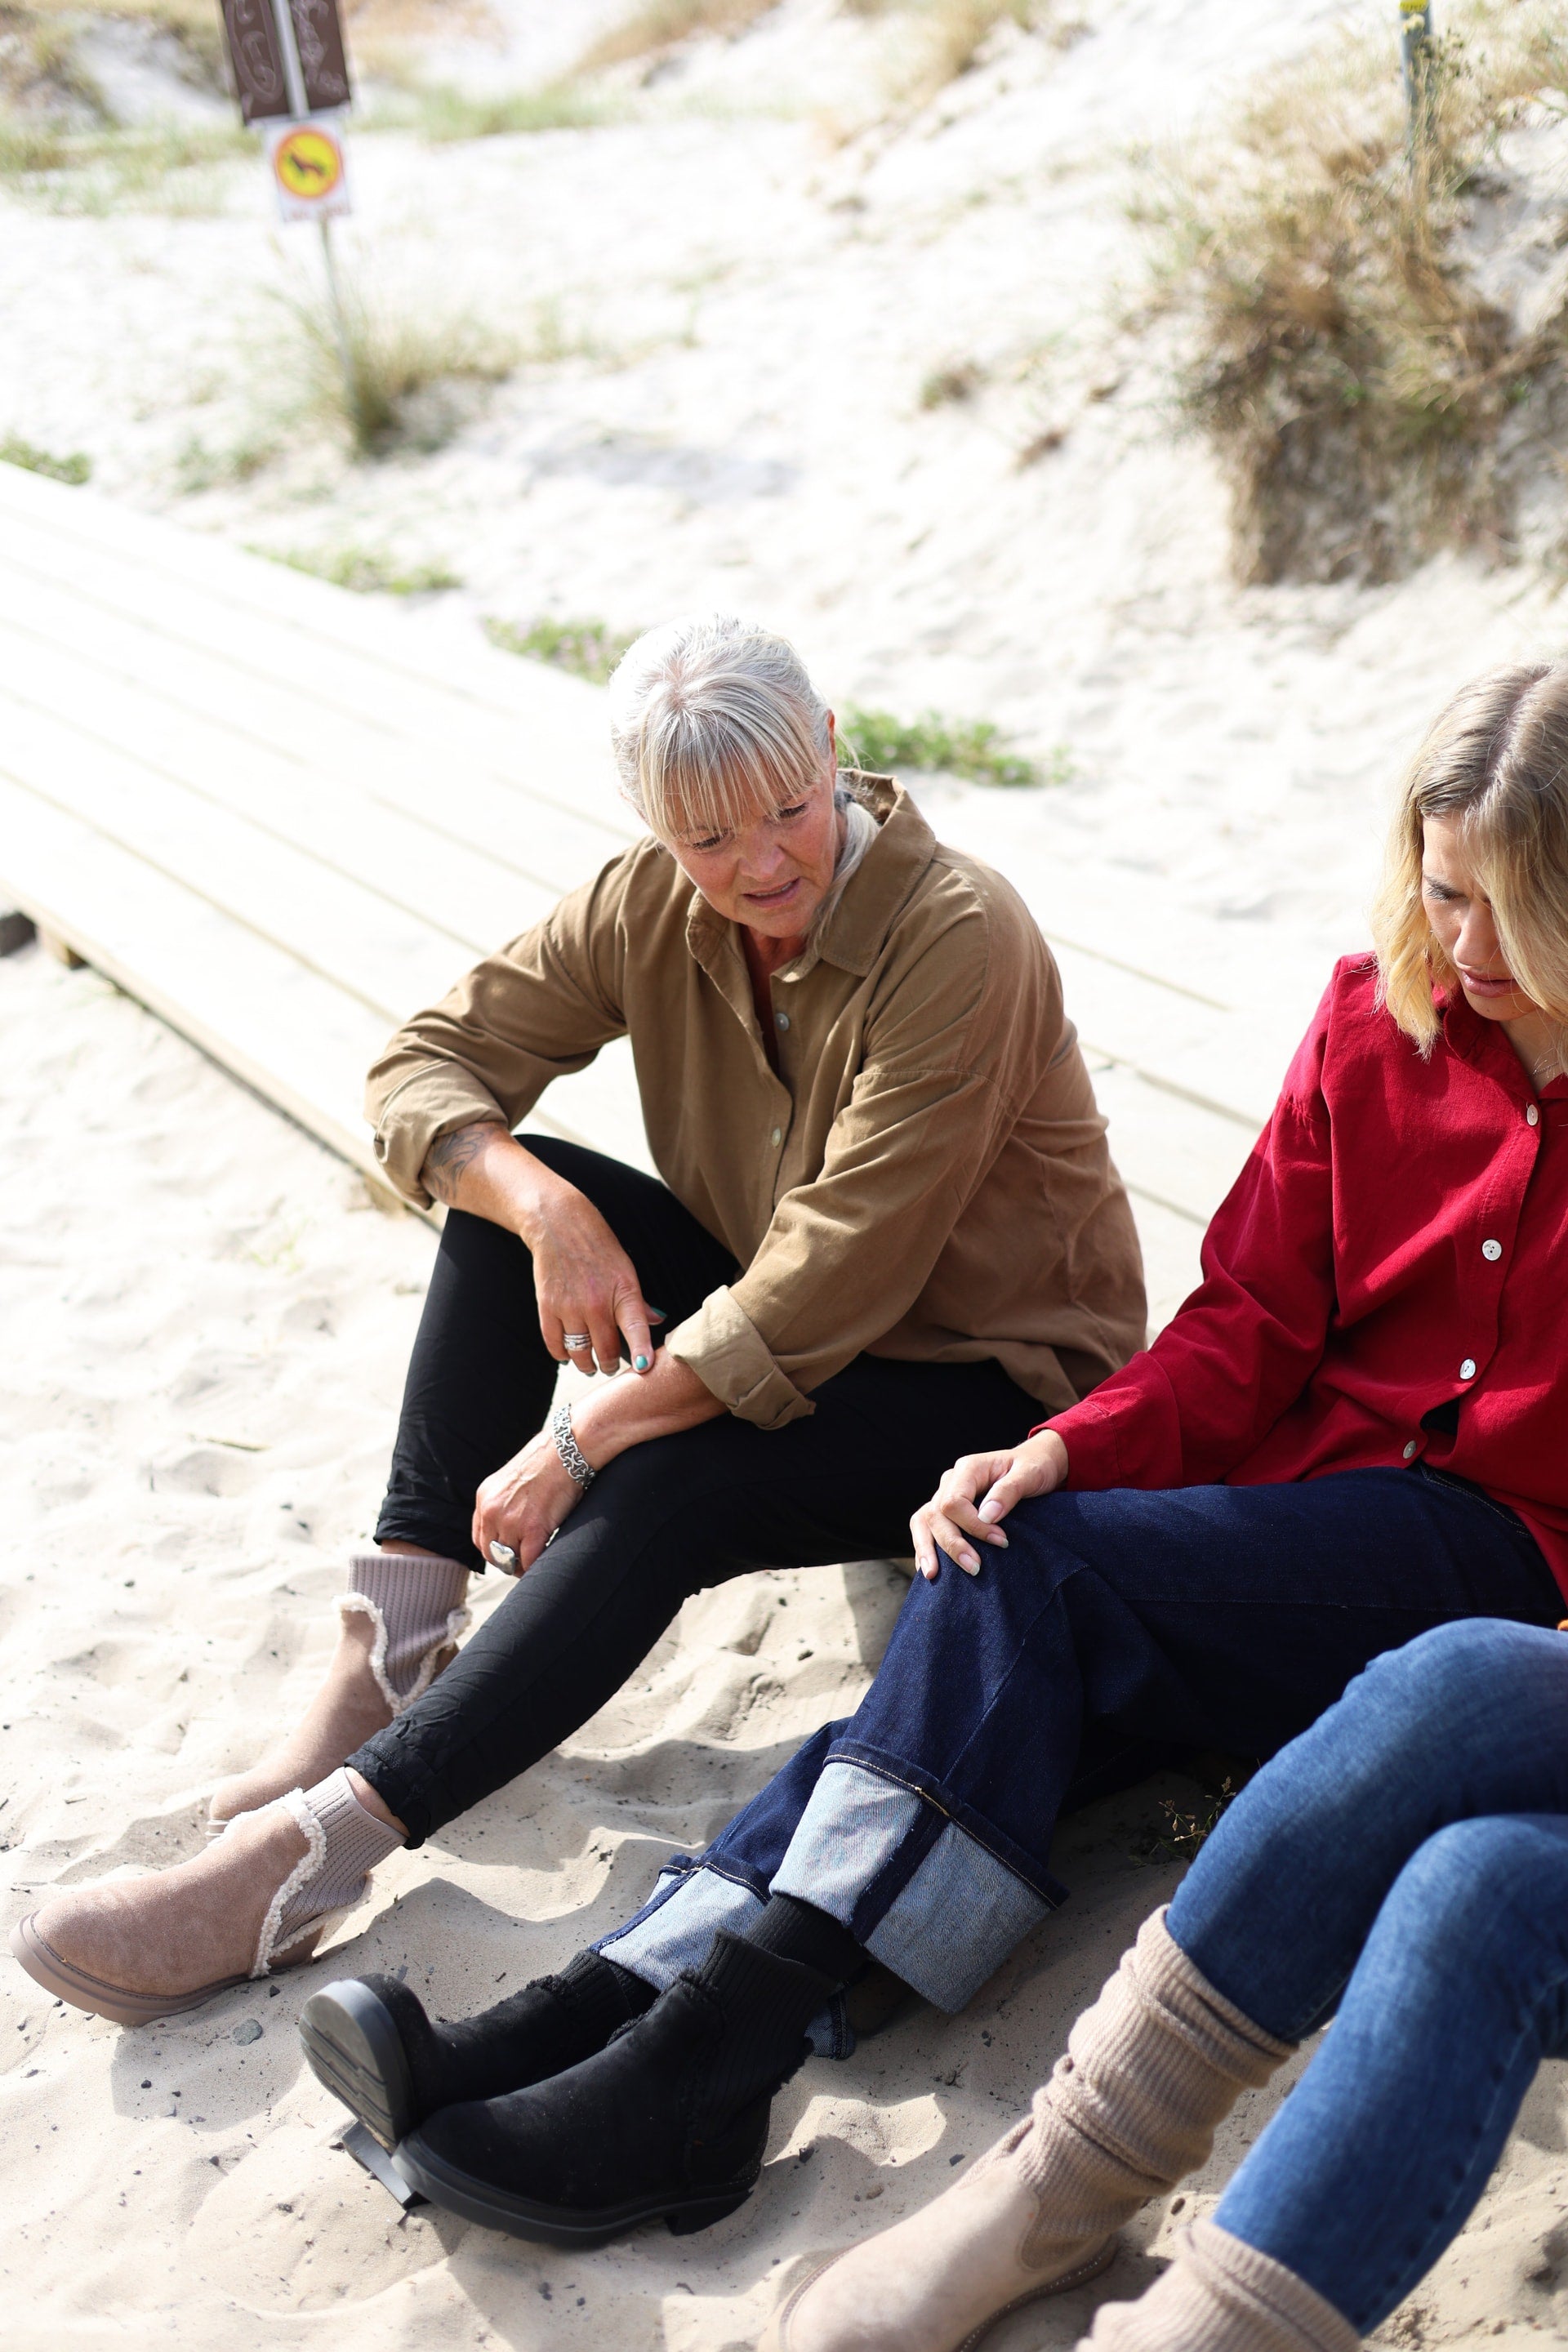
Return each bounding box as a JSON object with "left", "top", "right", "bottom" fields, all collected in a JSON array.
[{"left": 760, "top": 1912, "right": 1290, "bottom": 2352}]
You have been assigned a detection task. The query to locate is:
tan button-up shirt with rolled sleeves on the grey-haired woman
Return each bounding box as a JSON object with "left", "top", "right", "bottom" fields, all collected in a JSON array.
[{"left": 367, "top": 776, "right": 1145, "bottom": 1430}]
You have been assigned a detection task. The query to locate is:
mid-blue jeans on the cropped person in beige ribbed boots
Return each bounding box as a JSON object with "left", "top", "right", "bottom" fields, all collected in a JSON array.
[{"left": 1169, "top": 1620, "right": 1568, "bottom": 2336}]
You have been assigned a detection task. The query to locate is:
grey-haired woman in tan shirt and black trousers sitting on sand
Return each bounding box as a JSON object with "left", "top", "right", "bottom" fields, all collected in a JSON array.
[{"left": 14, "top": 618, "right": 1145, "bottom": 2023}]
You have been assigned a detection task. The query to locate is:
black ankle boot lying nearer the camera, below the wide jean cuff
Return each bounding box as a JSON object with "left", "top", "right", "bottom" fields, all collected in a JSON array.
[{"left": 397, "top": 1931, "right": 837, "bottom": 2246}]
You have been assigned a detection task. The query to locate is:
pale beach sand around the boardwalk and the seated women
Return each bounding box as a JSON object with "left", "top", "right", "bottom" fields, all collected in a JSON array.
[{"left": 0, "top": 0, "right": 1568, "bottom": 2352}]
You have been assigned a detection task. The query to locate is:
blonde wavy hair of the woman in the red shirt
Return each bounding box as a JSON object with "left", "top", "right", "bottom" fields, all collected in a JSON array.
[{"left": 1373, "top": 661, "right": 1568, "bottom": 1054}]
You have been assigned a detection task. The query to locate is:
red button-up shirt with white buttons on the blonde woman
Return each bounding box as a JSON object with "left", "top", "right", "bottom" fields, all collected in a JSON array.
[{"left": 1041, "top": 955, "right": 1568, "bottom": 1595}]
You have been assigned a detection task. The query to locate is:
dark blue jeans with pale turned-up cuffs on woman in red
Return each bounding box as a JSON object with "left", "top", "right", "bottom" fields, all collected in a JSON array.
[{"left": 607, "top": 1465, "right": 1563, "bottom": 2047}]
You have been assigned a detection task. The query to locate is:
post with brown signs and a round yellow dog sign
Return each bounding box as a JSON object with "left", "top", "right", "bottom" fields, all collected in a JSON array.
[{"left": 223, "top": 0, "right": 355, "bottom": 404}]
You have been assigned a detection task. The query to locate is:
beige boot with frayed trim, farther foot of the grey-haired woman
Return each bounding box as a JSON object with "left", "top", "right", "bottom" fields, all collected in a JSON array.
[{"left": 207, "top": 1552, "right": 468, "bottom": 1834}]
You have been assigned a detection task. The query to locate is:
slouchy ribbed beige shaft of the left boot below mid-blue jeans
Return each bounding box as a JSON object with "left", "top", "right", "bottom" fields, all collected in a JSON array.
[{"left": 1013, "top": 1910, "right": 1295, "bottom": 2267}]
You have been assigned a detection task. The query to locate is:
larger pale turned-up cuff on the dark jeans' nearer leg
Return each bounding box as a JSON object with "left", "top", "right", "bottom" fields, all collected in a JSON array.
[{"left": 773, "top": 1745, "right": 1065, "bottom": 2016}]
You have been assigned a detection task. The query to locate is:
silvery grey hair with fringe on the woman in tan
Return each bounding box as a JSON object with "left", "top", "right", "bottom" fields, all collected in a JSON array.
[{"left": 609, "top": 614, "right": 835, "bottom": 840}]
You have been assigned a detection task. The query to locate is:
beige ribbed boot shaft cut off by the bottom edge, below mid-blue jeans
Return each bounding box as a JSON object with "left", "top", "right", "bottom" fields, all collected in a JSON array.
[{"left": 1079, "top": 2221, "right": 1361, "bottom": 2352}]
